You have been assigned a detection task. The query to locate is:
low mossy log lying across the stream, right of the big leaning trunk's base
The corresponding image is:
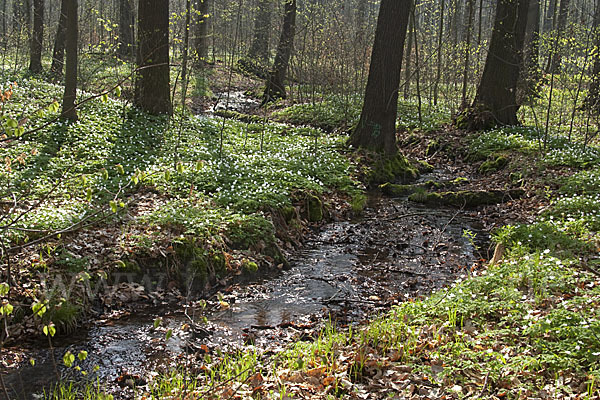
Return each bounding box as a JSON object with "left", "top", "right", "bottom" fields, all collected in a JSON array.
[{"left": 408, "top": 189, "right": 525, "bottom": 208}]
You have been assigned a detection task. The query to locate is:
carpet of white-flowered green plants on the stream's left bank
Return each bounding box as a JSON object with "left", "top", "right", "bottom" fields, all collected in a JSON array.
[{"left": 0, "top": 76, "right": 358, "bottom": 244}]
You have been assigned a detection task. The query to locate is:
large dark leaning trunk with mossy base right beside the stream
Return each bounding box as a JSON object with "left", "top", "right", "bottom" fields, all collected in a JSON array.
[{"left": 349, "top": 0, "right": 411, "bottom": 155}]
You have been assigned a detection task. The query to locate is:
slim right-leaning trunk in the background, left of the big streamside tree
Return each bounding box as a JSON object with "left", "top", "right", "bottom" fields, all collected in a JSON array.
[{"left": 263, "top": 0, "right": 296, "bottom": 105}]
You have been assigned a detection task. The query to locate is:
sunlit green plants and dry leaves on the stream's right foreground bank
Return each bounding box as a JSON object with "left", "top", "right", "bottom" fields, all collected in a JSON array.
[{"left": 143, "top": 130, "right": 600, "bottom": 399}]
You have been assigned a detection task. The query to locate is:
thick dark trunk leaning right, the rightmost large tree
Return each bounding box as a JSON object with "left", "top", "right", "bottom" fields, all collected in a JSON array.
[{"left": 460, "top": 0, "right": 529, "bottom": 129}]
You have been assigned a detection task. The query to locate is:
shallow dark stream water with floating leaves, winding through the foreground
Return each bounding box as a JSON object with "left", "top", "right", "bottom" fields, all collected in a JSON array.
[{"left": 4, "top": 193, "right": 487, "bottom": 399}]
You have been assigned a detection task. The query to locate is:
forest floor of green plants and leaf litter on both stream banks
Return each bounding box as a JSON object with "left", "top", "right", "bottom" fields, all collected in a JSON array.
[{"left": 0, "top": 64, "right": 600, "bottom": 399}]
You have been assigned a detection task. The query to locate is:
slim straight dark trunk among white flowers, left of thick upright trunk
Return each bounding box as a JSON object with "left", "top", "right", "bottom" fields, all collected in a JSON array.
[{"left": 62, "top": 0, "right": 79, "bottom": 121}]
